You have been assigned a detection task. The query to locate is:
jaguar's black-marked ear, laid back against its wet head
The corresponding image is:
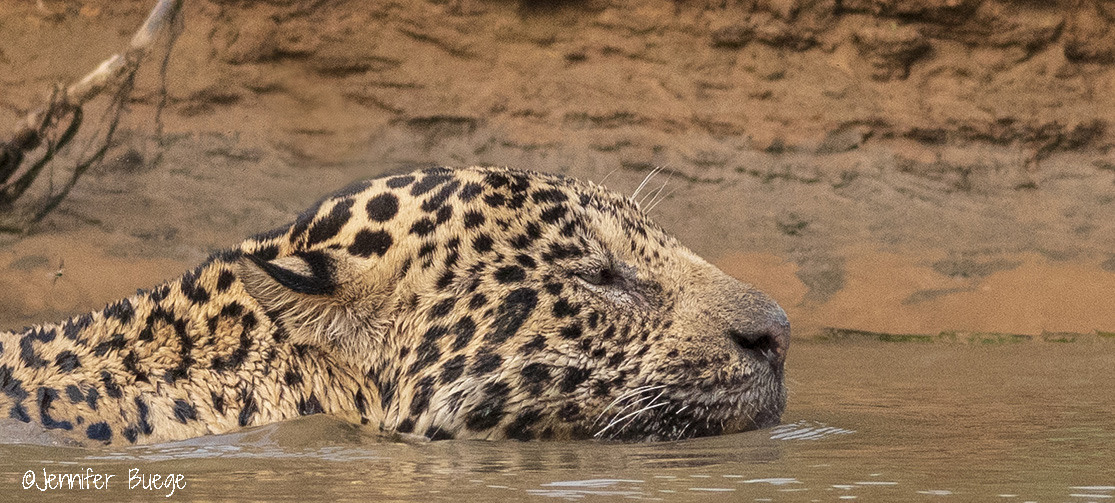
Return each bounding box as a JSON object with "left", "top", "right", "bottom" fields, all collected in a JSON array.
[{"left": 239, "top": 250, "right": 396, "bottom": 362}]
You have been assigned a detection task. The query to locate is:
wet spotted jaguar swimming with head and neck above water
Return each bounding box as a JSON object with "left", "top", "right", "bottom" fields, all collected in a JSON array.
[{"left": 0, "top": 167, "right": 789, "bottom": 444}]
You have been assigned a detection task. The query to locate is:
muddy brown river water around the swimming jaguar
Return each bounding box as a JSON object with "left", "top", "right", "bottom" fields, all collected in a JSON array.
[{"left": 0, "top": 341, "right": 1115, "bottom": 502}]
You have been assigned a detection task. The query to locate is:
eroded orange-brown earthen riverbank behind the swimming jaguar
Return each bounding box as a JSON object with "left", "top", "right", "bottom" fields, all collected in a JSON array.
[{"left": 0, "top": 0, "right": 1115, "bottom": 337}]
